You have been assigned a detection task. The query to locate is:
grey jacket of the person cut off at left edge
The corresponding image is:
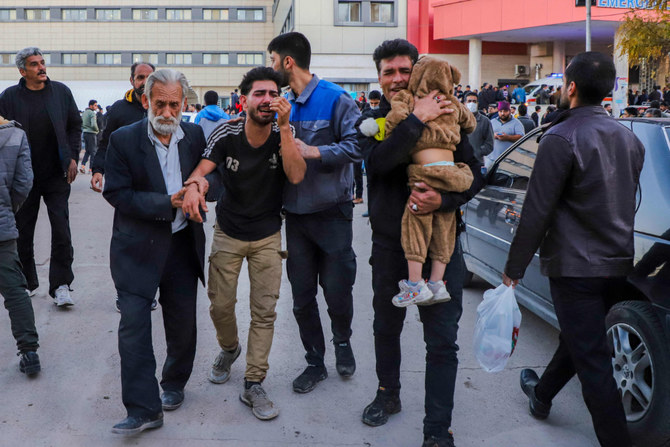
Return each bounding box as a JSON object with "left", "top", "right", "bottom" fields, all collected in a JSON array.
[{"left": 0, "top": 118, "right": 33, "bottom": 242}]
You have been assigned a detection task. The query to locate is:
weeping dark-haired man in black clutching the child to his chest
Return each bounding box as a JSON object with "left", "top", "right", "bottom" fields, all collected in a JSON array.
[{"left": 358, "top": 39, "right": 483, "bottom": 447}]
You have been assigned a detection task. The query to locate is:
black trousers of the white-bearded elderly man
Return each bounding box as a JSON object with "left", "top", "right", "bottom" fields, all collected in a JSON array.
[{"left": 117, "top": 227, "right": 199, "bottom": 416}]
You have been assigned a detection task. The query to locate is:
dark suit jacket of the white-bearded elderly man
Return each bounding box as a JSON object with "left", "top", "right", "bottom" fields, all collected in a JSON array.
[{"left": 102, "top": 119, "right": 206, "bottom": 299}]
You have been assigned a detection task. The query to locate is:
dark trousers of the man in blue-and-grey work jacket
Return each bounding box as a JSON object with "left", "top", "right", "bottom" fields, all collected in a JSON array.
[{"left": 286, "top": 202, "right": 356, "bottom": 366}]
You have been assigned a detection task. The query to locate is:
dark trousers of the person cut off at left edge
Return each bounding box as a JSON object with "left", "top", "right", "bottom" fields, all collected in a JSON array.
[{"left": 0, "top": 239, "right": 39, "bottom": 352}]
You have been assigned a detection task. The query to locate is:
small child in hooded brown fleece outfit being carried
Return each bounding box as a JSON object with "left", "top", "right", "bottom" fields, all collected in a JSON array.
[{"left": 386, "top": 56, "right": 477, "bottom": 307}]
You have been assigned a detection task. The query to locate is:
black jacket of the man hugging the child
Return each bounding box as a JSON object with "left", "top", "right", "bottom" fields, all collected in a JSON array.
[{"left": 356, "top": 96, "right": 484, "bottom": 252}]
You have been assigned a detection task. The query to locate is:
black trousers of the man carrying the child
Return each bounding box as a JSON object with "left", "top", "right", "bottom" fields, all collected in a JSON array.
[{"left": 370, "top": 239, "right": 465, "bottom": 437}]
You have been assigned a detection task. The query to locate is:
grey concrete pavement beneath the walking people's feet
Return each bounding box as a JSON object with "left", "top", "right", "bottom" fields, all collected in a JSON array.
[{"left": 0, "top": 175, "right": 597, "bottom": 447}]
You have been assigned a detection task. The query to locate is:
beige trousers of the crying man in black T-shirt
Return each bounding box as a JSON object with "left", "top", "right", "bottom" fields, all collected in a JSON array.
[{"left": 207, "top": 225, "right": 282, "bottom": 382}]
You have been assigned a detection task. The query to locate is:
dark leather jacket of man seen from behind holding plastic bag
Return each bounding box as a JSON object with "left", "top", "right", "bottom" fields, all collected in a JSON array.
[{"left": 505, "top": 105, "right": 644, "bottom": 279}]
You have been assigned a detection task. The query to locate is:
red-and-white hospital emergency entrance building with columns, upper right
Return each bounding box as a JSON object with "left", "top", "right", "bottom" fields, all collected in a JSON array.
[{"left": 408, "top": 0, "right": 668, "bottom": 114}]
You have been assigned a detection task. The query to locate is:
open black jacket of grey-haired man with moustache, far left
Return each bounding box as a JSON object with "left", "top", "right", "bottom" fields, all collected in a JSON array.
[{"left": 0, "top": 78, "right": 81, "bottom": 175}]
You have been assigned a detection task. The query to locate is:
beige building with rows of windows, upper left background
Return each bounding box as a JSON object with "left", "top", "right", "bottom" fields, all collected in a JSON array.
[{"left": 0, "top": 0, "right": 274, "bottom": 108}]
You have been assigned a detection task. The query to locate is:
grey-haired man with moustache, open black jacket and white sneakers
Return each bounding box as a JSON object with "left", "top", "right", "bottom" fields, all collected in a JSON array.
[{"left": 0, "top": 47, "right": 81, "bottom": 307}]
